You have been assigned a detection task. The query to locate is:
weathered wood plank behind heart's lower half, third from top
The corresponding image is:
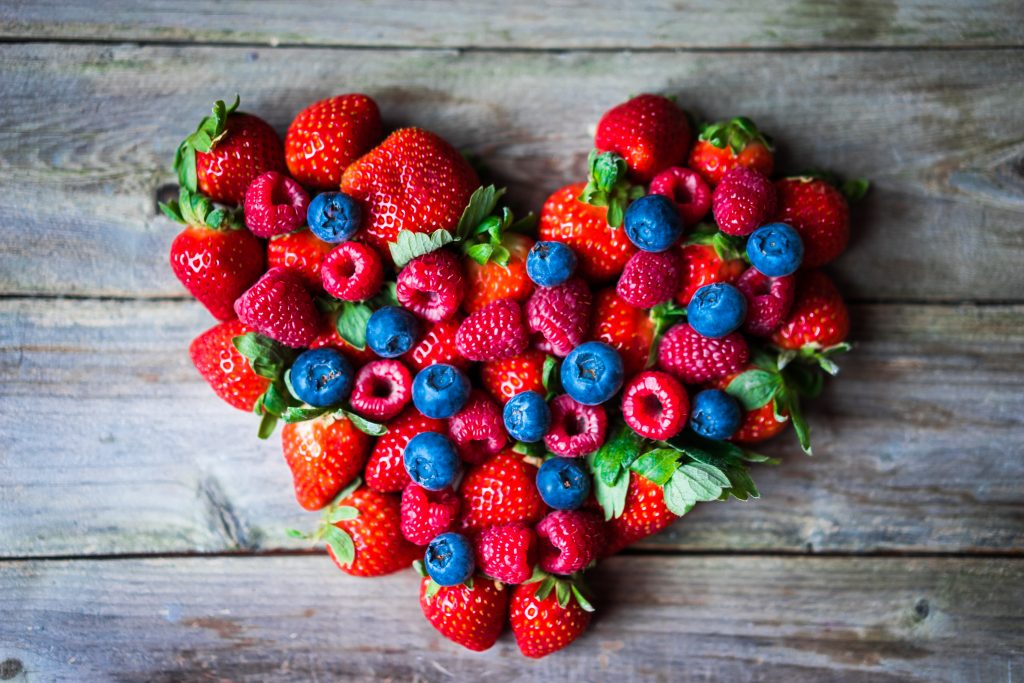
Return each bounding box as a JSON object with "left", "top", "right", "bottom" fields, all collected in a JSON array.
[{"left": 0, "top": 299, "right": 1024, "bottom": 556}]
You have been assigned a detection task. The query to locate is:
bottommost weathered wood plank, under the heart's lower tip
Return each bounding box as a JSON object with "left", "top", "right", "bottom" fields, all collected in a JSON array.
[{"left": 0, "top": 556, "right": 1024, "bottom": 683}]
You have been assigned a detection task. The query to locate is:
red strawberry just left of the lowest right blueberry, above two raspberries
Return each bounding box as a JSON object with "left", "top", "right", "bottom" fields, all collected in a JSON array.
[{"left": 459, "top": 451, "right": 545, "bottom": 531}]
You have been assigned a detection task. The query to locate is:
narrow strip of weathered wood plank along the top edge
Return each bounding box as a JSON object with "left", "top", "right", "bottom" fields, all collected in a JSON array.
[{"left": 0, "top": 0, "right": 1024, "bottom": 48}]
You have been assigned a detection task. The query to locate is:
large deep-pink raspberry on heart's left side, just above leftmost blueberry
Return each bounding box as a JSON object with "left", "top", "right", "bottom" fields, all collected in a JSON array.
[{"left": 234, "top": 267, "right": 322, "bottom": 348}]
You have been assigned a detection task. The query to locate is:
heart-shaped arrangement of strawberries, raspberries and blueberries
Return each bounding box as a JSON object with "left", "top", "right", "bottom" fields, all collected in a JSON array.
[{"left": 162, "top": 94, "right": 866, "bottom": 657}]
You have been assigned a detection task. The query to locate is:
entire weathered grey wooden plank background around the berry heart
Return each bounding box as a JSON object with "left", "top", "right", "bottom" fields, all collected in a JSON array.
[{"left": 0, "top": 0, "right": 1024, "bottom": 683}]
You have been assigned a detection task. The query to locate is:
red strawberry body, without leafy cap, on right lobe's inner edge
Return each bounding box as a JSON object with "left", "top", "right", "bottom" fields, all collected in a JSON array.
[{"left": 540, "top": 182, "right": 637, "bottom": 284}]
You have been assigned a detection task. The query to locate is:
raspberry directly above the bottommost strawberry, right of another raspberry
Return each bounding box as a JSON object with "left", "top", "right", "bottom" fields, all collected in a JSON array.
[{"left": 537, "top": 510, "right": 604, "bottom": 574}]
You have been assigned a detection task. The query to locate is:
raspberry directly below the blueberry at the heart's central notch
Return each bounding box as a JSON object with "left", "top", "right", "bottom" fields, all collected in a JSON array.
[{"left": 526, "top": 278, "right": 593, "bottom": 357}]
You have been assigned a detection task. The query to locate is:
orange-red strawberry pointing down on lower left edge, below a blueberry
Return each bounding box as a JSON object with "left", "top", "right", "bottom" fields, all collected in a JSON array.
[{"left": 281, "top": 417, "right": 373, "bottom": 510}]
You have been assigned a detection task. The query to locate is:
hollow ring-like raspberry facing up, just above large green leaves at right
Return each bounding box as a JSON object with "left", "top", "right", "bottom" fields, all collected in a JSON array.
[{"left": 623, "top": 371, "right": 690, "bottom": 439}]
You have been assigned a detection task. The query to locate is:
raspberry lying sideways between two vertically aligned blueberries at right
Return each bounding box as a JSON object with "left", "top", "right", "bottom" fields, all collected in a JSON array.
[{"left": 657, "top": 323, "right": 750, "bottom": 384}]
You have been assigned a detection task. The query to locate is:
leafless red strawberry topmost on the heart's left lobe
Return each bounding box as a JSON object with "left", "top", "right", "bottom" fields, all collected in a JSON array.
[{"left": 285, "top": 93, "right": 384, "bottom": 189}]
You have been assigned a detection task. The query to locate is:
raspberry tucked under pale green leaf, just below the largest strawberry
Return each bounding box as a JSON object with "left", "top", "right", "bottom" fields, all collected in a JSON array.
[{"left": 396, "top": 250, "right": 466, "bottom": 323}]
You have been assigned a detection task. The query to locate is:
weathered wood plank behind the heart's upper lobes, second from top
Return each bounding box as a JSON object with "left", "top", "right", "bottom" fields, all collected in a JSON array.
[{"left": 0, "top": 44, "right": 1024, "bottom": 300}]
